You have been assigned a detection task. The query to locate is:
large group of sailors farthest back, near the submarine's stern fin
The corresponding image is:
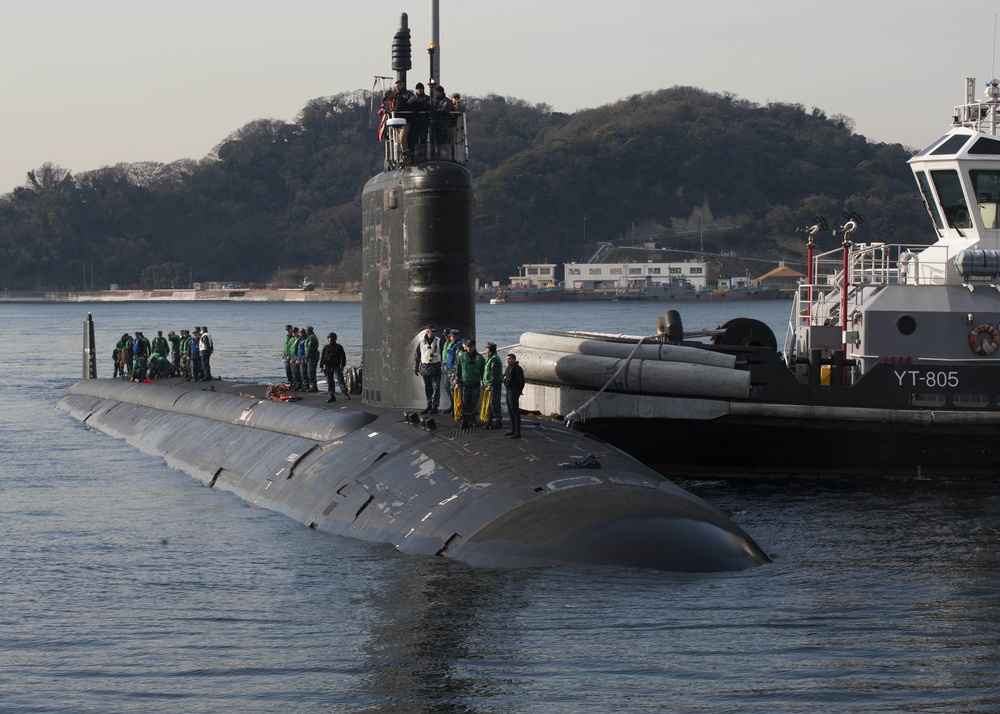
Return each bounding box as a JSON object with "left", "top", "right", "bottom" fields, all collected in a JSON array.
[{"left": 111, "top": 325, "right": 215, "bottom": 382}]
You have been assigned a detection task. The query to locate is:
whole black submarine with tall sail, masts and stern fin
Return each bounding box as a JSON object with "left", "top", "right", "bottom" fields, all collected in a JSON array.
[{"left": 58, "top": 1, "right": 769, "bottom": 572}]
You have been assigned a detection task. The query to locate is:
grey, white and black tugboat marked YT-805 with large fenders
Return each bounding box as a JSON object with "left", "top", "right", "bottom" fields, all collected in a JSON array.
[{"left": 515, "top": 79, "right": 1000, "bottom": 478}]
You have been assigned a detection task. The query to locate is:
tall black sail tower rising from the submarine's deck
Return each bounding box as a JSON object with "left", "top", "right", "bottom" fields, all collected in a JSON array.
[{"left": 361, "top": 161, "right": 476, "bottom": 408}]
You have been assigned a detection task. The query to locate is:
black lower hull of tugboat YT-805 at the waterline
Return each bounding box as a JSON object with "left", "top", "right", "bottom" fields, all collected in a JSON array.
[{"left": 584, "top": 414, "right": 1000, "bottom": 479}]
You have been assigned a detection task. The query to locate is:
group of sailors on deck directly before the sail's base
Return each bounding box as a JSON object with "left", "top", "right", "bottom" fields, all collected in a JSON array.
[{"left": 413, "top": 325, "right": 524, "bottom": 439}]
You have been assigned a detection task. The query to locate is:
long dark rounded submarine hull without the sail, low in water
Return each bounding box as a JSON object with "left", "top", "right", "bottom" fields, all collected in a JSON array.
[{"left": 59, "top": 379, "right": 768, "bottom": 572}]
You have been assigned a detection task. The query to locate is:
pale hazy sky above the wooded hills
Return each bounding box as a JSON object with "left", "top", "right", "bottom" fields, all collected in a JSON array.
[{"left": 0, "top": 0, "right": 1000, "bottom": 194}]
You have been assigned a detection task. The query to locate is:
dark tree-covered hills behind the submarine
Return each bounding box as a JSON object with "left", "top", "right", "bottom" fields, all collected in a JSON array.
[{"left": 0, "top": 87, "right": 932, "bottom": 290}]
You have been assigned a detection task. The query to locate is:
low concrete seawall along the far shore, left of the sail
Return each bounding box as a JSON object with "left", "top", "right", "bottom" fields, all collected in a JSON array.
[{"left": 0, "top": 290, "right": 361, "bottom": 303}]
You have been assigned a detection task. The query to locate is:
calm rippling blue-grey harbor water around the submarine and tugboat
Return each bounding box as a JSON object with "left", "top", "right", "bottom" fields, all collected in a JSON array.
[{"left": 0, "top": 301, "right": 1000, "bottom": 712}]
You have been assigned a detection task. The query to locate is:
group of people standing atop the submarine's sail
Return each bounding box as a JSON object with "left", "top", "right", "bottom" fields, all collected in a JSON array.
[{"left": 378, "top": 80, "right": 465, "bottom": 159}]
